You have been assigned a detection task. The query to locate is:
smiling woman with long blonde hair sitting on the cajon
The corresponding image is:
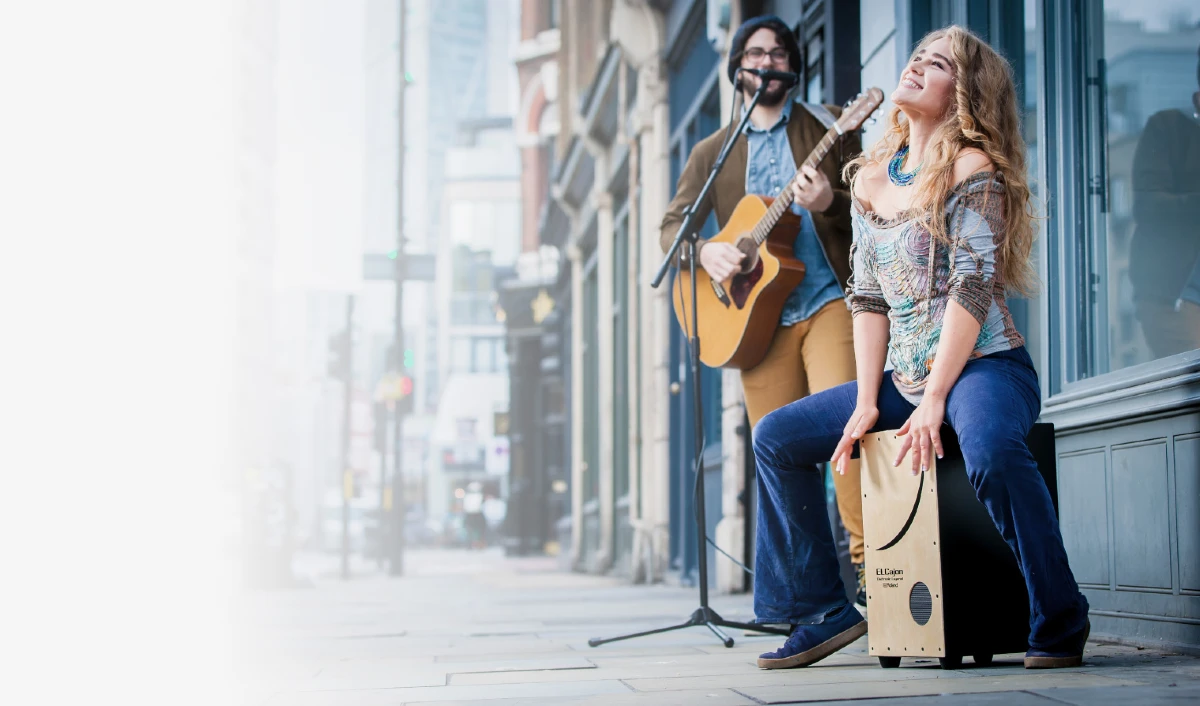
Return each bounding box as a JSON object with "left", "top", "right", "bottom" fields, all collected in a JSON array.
[{"left": 754, "top": 26, "right": 1090, "bottom": 669}]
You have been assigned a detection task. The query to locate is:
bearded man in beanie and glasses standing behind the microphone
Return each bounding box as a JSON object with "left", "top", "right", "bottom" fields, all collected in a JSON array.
[{"left": 660, "top": 16, "right": 866, "bottom": 610}]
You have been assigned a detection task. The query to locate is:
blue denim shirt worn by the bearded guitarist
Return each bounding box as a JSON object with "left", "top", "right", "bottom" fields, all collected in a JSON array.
[{"left": 746, "top": 96, "right": 844, "bottom": 327}]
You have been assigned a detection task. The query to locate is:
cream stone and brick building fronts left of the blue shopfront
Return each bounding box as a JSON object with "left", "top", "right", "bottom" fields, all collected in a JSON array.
[{"left": 506, "top": 0, "right": 686, "bottom": 580}]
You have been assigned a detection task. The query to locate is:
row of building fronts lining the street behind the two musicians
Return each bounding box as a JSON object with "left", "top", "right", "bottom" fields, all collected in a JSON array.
[{"left": 511, "top": 0, "right": 1200, "bottom": 647}]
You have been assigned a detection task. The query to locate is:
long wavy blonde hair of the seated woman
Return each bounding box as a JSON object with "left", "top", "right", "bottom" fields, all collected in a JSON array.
[{"left": 842, "top": 25, "right": 1038, "bottom": 295}]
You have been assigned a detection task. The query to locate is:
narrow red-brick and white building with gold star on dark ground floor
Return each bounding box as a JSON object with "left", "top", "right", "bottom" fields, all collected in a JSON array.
[{"left": 500, "top": 0, "right": 570, "bottom": 555}]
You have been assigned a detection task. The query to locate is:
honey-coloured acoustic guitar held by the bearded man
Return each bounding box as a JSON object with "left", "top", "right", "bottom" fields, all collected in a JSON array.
[{"left": 672, "top": 88, "right": 883, "bottom": 370}]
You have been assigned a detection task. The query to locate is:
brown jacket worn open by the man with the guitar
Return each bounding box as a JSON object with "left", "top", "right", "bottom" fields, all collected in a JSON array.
[{"left": 659, "top": 100, "right": 863, "bottom": 291}]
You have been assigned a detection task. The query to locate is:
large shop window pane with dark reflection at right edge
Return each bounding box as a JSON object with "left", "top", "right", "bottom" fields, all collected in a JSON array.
[{"left": 1096, "top": 1, "right": 1200, "bottom": 372}]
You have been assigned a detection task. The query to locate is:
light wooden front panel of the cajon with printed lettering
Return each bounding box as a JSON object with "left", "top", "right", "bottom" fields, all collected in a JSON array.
[{"left": 859, "top": 431, "right": 946, "bottom": 657}]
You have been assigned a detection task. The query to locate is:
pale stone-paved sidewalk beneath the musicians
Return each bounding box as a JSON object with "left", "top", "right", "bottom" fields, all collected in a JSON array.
[{"left": 235, "top": 550, "right": 1200, "bottom": 706}]
